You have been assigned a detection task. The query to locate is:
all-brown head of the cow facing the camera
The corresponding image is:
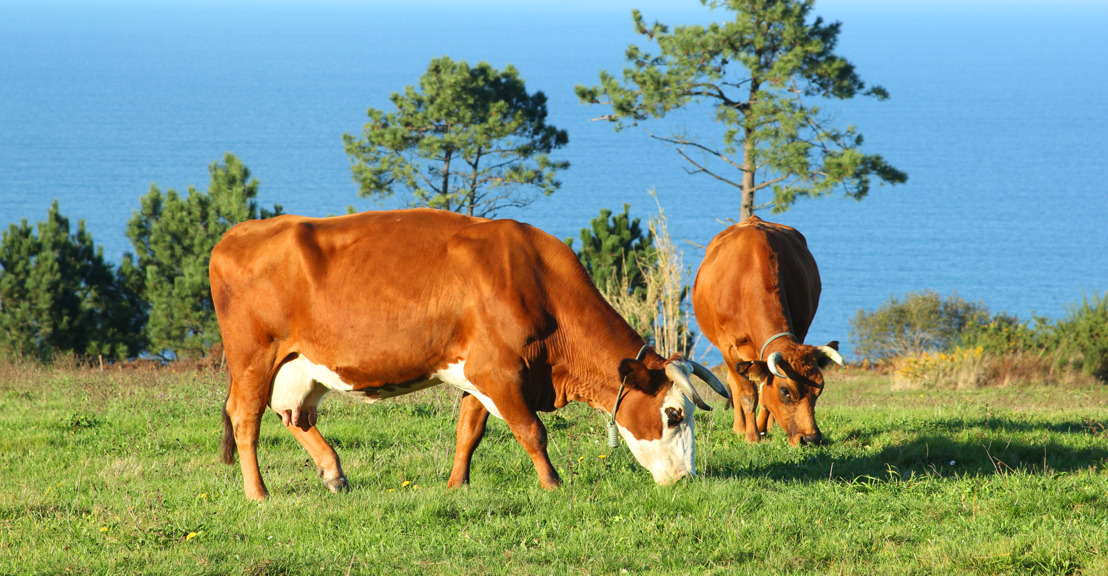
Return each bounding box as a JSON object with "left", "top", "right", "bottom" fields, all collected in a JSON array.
[{"left": 735, "top": 342, "right": 842, "bottom": 446}]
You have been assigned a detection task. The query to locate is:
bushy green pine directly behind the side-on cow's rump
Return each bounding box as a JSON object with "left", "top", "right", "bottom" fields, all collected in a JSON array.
[{"left": 127, "top": 154, "right": 281, "bottom": 358}]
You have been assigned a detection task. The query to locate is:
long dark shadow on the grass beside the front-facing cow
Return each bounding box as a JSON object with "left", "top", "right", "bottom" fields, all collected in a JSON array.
[{"left": 702, "top": 418, "right": 1108, "bottom": 482}]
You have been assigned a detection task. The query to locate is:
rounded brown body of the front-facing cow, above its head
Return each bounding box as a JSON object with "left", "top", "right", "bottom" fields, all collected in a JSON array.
[{"left": 693, "top": 216, "right": 821, "bottom": 359}]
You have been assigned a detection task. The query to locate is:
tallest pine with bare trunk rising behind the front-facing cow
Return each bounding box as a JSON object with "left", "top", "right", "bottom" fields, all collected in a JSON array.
[{"left": 576, "top": 0, "right": 907, "bottom": 219}]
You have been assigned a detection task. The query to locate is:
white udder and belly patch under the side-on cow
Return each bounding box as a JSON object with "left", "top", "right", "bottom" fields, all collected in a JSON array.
[{"left": 269, "top": 356, "right": 503, "bottom": 429}]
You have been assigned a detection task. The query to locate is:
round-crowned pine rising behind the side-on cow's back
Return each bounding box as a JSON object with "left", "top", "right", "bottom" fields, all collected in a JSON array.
[{"left": 342, "top": 56, "right": 570, "bottom": 216}]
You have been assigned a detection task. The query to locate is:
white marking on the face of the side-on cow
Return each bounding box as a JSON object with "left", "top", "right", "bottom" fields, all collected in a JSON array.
[{"left": 619, "top": 388, "right": 696, "bottom": 484}]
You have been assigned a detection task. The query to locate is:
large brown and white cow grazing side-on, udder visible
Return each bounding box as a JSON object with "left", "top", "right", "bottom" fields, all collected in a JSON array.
[{"left": 211, "top": 209, "right": 727, "bottom": 500}]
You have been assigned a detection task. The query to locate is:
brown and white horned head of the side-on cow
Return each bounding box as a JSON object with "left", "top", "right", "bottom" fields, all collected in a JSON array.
[{"left": 616, "top": 354, "right": 730, "bottom": 484}]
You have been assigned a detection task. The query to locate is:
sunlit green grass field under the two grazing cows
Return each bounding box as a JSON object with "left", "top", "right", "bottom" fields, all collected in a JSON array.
[{"left": 0, "top": 364, "right": 1108, "bottom": 576}]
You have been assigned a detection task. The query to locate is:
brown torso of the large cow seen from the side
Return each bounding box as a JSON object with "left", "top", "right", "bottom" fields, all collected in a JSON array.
[{"left": 212, "top": 209, "right": 602, "bottom": 392}]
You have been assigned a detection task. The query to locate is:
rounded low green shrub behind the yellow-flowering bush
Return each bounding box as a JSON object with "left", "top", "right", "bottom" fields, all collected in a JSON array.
[{"left": 850, "top": 290, "right": 989, "bottom": 360}]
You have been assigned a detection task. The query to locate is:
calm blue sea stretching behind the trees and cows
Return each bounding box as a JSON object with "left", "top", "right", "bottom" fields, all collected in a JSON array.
[{"left": 0, "top": 0, "right": 1108, "bottom": 361}]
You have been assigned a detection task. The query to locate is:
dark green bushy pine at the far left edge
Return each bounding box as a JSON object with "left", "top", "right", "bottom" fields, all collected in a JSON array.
[{"left": 0, "top": 200, "right": 144, "bottom": 361}]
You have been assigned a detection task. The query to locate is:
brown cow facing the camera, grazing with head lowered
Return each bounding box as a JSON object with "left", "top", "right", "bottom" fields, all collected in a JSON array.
[{"left": 693, "top": 216, "right": 842, "bottom": 445}]
